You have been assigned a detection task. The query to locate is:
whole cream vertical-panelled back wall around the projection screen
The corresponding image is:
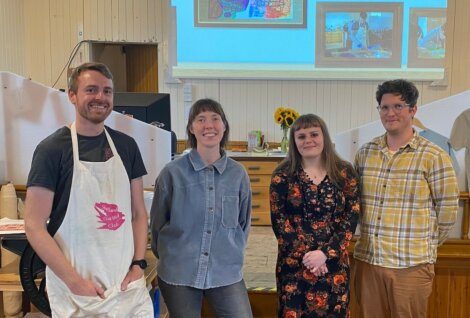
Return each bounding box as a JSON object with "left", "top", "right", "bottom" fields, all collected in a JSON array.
[{"left": 0, "top": 0, "right": 470, "bottom": 141}]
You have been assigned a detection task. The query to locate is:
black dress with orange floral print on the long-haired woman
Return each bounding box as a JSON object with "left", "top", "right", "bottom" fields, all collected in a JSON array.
[{"left": 270, "top": 165, "right": 360, "bottom": 318}]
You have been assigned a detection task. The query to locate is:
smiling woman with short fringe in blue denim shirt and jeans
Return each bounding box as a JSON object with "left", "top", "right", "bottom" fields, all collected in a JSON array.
[{"left": 151, "top": 99, "right": 252, "bottom": 318}]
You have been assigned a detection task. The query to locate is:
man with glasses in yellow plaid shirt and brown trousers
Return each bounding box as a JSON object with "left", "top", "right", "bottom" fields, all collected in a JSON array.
[{"left": 354, "top": 80, "right": 459, "bottom": 318}]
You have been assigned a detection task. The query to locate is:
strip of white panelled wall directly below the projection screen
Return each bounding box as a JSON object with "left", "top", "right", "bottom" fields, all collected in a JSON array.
[{"left": 165, "top": 79, "right": 449, "bottom": 141}]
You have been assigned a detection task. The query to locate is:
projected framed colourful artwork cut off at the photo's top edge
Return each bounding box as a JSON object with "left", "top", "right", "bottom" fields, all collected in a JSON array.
[{"left": 194, "top": 0, "right": 307, "bottom": 28}]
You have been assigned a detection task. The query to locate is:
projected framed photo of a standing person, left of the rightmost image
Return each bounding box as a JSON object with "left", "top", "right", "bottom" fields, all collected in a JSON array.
[{"left": 315, "top": 2, "right": 403, "bottom": 67}]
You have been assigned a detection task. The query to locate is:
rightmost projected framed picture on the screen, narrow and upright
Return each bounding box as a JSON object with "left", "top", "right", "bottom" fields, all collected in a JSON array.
[{"left": 408, "top": 8, "right": 446, "bottom": 68}]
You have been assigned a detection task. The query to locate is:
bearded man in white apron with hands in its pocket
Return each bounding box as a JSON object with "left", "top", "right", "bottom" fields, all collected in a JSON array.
[{"left": 25, "top": 63, "right": 153, "bottom": 318}]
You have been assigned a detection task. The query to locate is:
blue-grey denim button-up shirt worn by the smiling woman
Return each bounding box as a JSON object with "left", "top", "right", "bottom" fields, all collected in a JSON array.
[{"left": 150, "top": 149, "right": 251, "bottom": 289}]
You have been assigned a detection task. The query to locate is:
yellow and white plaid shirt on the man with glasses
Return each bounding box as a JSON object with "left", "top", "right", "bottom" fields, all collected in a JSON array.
[{"left": 354, "top": 131, "right": 459, "bottom": 268}]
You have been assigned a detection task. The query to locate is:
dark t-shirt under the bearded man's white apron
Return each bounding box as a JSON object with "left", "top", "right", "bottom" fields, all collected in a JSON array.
[{"left": 27, "top": 127, "right": 147, "bottom": 232}]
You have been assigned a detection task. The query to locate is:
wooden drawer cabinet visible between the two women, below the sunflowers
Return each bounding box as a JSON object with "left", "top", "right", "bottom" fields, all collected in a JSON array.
[{"left": 232, "top": 156, "right": 283, "bottom": 225}]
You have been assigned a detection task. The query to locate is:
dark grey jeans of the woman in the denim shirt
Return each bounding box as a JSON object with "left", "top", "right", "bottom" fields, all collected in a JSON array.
[{"left": 158, "top": 277, "right": 253, "bottom": 318}]
